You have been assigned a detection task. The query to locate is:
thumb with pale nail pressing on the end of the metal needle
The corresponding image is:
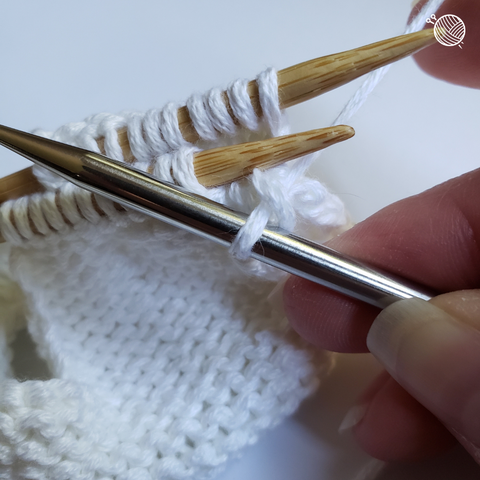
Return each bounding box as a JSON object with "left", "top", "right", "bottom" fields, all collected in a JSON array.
[{"left": 367, "top": 290, "right": 480, "bottom": 463}]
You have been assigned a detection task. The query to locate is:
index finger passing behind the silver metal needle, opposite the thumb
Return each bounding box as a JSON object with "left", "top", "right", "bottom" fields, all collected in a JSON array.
[{"left": 283, "top": 169, "right": 480, "bottom": 352}]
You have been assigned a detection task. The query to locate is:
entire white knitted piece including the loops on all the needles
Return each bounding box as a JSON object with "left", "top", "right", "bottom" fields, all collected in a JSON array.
[{"left": 0, "top": 70, "right": 346, "bottom": 480}]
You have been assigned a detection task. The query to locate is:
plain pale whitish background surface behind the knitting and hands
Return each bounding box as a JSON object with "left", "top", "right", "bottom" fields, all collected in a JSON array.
[{"left": 0, "top": 0, "right": 480, "bottom": 480}]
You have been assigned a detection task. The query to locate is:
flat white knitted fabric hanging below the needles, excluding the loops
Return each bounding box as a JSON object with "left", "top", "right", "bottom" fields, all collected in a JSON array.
[{"left": 0, "top": 218, "right": 334, "bottom": 479}]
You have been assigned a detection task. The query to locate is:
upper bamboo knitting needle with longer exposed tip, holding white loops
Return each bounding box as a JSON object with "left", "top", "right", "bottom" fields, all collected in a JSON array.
[{"left": 0, "top": 29, "right": 436, "bottom": 203}]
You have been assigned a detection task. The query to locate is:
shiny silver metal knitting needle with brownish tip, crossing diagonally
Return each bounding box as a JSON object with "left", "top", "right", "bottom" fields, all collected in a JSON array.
[{"left": 0, "top": 127, "right": 431, "bottom": 308}]
